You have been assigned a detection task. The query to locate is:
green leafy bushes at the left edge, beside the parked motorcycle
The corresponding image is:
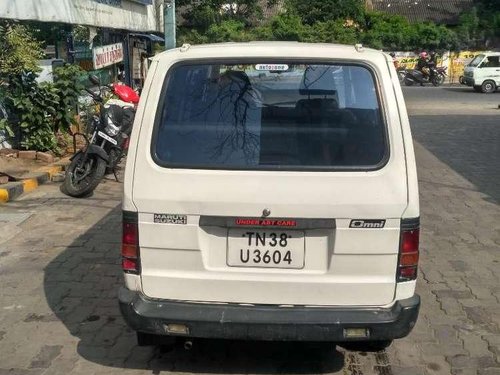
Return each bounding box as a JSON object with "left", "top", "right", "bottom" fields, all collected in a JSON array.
[{"left": 0, "top": 23, "right": 83, "bottom": 151}]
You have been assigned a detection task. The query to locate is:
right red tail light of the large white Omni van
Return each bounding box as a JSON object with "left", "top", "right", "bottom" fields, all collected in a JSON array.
[{"left": 397, "top": 218, "right": 420, "bottom": 282}]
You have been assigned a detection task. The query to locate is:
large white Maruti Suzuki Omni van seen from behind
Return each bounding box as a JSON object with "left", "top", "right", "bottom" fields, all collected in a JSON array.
[{"left": 119, "top": 42, "right": 420, "bottom": 347}]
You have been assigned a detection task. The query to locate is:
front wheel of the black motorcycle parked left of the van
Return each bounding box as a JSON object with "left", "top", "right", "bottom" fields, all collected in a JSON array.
[{"left": 61, "top": 153, "right": 106, "bottom": 198}]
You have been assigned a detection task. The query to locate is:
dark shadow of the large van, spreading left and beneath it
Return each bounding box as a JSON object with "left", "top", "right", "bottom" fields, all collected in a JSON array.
[{"left": 44, "top": 207, "right": 344, "bottom": 374}]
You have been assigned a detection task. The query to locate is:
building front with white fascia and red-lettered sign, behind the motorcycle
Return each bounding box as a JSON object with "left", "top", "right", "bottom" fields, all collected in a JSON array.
[{"left": 0, "top": 0, "right": 163, "bottom": 89}]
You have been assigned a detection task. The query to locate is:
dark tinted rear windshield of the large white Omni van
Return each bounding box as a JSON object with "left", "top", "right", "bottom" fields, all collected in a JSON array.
[{"left": 152, "top": 63, "right": 387, "bottom": 170}]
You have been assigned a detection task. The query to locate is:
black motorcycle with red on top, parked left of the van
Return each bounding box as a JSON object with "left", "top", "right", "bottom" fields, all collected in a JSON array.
[{"left": 61, "top": 76, "right": 139, "bottom": 198}]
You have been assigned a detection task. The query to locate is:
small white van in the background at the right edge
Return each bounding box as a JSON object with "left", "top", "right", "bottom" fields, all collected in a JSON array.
[{"left": 461, "top": 52, "right": 500, "bottom": 93}]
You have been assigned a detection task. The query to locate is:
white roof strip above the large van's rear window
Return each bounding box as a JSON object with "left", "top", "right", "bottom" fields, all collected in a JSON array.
[{"left": 152, "top": 42, "right": 389, "bottom": 62}]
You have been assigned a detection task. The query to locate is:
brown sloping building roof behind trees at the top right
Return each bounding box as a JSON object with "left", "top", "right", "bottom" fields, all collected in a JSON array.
[{"left": 368, "top": 0, "right": 474, "bottom": 25}]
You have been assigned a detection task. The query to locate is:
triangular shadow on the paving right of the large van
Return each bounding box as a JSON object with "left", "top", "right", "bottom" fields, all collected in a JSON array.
[{"left": 410, "top": 114, "right": 500, "bottom": 204}]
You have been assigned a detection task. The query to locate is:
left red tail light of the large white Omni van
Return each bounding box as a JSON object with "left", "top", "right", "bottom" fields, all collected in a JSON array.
[{"left": 121, "top": 211, "right": 141, "bottom": 274}]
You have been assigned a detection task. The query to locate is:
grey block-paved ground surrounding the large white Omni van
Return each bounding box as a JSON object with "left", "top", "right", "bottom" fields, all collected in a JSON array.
[{"left": 0, "top": 87, "right": 500, "bottom": 375}]
